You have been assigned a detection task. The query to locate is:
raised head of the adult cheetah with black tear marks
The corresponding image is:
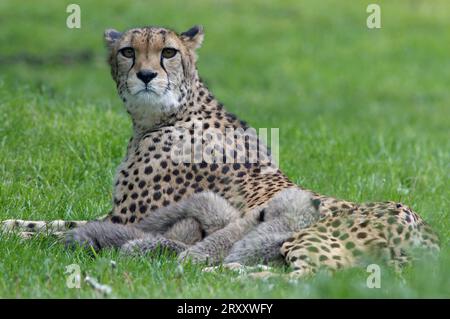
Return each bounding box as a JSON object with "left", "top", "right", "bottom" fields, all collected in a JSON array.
[{"left": 104, "top": 26, "right": 203, "bottom": 127}]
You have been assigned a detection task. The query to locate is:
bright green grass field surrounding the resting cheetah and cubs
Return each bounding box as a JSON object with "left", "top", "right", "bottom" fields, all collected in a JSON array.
[{"left": 0, "top": 0, "right": 450, "bottom": 298}]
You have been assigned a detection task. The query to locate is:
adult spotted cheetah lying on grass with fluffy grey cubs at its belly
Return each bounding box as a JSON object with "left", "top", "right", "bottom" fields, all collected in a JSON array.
[{"left": 2, "top": 26, "right": 439, "bottom": 276}]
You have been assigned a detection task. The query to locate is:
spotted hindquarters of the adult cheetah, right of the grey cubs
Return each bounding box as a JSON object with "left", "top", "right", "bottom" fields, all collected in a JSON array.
[{"left": 281, "top": 200, "right": 439, "bottom": 276}]
